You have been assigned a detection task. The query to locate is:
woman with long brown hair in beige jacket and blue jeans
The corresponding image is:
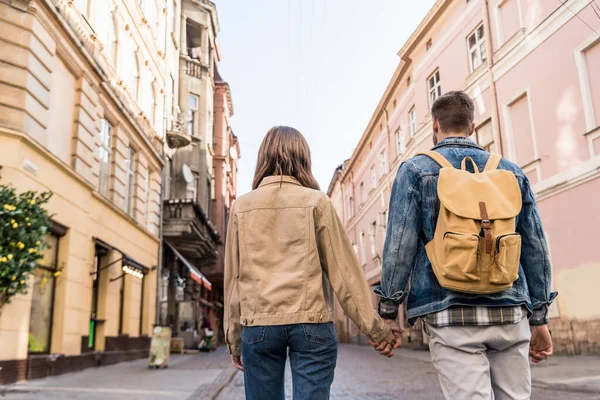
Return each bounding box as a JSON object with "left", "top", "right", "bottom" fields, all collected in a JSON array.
[{"left": 224, "top": 126, "right": 396, "bottom": 400}]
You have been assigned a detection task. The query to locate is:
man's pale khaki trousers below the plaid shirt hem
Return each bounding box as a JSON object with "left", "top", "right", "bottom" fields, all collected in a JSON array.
[{"left": 427, "top": 319, "right": 531, "bottom": 400}]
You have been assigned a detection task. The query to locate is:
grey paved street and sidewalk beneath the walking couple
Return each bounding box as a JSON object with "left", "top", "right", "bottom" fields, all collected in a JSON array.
[{"left": 0, "top": 345, "right": 600, "bottom": 400}]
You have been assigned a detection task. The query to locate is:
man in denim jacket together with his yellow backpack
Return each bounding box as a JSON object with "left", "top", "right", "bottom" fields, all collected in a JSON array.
[{"left": 376, "top": 92, "right": 556, "bottom": 400}]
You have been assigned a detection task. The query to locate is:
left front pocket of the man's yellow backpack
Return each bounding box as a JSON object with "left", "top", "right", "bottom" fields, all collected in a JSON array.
[{"left": 441, "top": 232, "right": 480, "bottom": 282}]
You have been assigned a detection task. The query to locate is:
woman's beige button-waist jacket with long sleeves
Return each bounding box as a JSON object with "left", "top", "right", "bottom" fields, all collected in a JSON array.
[{"left": 224, "top": 176, "right": 389, "bottom": 355}]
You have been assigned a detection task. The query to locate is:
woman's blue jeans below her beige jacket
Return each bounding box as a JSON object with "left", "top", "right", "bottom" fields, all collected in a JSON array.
[{"left": 242, "top": 322, "right": 337, "bottom": 400}]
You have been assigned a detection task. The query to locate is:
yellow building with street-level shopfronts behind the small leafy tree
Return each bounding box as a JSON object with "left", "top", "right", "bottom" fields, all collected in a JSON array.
[{"left": 0, "top": 0, "right": 170, "bottom": 384}]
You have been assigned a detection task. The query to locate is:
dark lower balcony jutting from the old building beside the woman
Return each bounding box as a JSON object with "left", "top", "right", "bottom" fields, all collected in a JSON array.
[{"left": 163, "top": 199, "right": 222, "bottom": 267}]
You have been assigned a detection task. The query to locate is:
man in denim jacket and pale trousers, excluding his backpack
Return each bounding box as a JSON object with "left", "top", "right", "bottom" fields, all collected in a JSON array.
[{"left": 375, "top": 92, "right": 556, "bottom": 400}]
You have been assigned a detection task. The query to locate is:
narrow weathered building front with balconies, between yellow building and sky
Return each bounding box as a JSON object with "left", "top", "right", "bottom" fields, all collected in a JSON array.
[{"left": 159, "top": 0, "right": 239, "bottom": 348}]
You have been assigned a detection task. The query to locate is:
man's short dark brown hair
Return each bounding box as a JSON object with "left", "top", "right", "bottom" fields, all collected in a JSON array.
[{"left": 431, "top": 91, "right": 475, "bottom": 135}]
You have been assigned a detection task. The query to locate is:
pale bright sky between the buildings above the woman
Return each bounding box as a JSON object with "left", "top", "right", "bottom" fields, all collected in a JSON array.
[{"left": 214, "top": 0, "right": 435, "bottom": 195}]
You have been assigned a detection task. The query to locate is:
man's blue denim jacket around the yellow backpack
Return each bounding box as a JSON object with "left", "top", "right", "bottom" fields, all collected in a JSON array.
[{"left": 375, "top": 137, "right": 556, "bottom": 325}]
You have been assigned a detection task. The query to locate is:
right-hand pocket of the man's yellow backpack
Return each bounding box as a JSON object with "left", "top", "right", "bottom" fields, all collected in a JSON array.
[{"left": 490, "top": 233, "right": 521, "bottom": 285}]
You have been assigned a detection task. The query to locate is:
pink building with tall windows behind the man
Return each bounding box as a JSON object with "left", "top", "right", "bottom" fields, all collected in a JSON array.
[{"left": 329, "top": 0, "right": 600, "bottom": 354}]
